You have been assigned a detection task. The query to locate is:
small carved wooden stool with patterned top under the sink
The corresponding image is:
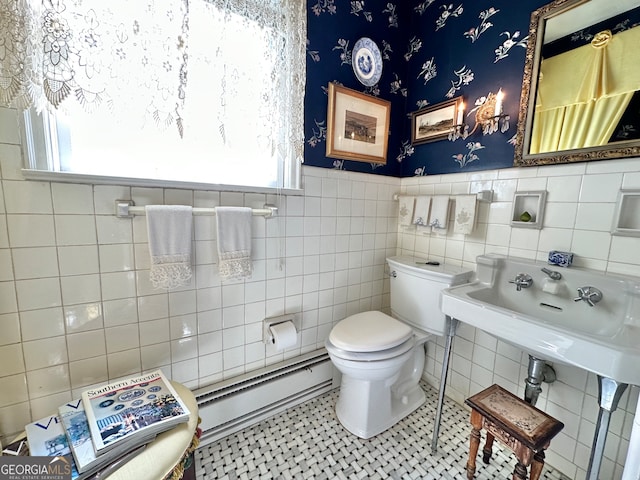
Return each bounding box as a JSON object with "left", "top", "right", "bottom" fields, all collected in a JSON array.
[{"left": 465, "top": 385, "right": 564, "bottom": 480}]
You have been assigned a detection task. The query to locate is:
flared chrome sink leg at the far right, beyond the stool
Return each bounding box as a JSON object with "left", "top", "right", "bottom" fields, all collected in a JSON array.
[{"left": 587, "top": 375, "right": 627, "bottom": 480}]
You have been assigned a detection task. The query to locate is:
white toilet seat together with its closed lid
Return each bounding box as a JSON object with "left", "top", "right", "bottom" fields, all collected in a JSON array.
[{"left": 327, "top": 311, "right": 414, "bottom": 361}]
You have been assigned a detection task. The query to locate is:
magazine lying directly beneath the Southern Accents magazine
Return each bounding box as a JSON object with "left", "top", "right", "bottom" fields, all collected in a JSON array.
[{"left": 58, "top": 399, "right": 155, "bottom": 473}]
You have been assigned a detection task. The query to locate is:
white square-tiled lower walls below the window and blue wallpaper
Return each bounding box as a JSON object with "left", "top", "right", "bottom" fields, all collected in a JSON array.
[{"left": 0, "top": 109, "right": 640, "bottom": 479}]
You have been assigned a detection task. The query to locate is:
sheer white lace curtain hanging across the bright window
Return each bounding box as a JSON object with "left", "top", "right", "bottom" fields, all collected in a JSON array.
[{"left": 0, "top": 0, "right": 306, "bottom": 169}]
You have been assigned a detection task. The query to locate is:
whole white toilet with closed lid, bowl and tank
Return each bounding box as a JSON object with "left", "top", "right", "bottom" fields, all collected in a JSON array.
[{"left": 326, "top": 257, "right": 472, "bottom": 438}]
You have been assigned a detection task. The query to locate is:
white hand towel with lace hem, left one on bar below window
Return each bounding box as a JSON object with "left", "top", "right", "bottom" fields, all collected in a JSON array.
[{"left": 145, "top": 205, "right": 193, "bottom": 288}]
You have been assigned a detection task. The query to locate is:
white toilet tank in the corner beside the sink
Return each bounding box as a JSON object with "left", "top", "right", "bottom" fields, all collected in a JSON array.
[{"left": 387, "top": 256, "right": 473, "bottom": 336}]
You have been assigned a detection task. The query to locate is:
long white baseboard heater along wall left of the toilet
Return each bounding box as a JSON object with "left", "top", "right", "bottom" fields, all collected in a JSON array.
[{"left": 193, "top": 348, "right": 333, "bottom": 446}]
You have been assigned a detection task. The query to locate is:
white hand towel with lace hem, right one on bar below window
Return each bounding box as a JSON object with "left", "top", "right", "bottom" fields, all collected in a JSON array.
[{"left": 216, "top": 207, "right": 253, "bottom": 280}]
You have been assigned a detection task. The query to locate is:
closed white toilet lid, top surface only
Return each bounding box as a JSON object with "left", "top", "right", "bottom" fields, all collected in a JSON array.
[{"left": 329, "top": 312, "right": 413, "bottom": 352}]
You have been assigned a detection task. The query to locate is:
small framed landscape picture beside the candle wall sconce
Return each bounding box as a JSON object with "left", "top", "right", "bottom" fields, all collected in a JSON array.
[{"left": 411, "top": 97, "right": 464, "bottom": 145}]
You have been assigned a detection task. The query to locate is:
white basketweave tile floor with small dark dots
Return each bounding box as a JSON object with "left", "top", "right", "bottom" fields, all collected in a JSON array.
[{"left": 195, "top": 383, "right": 569, "bottom": 480}]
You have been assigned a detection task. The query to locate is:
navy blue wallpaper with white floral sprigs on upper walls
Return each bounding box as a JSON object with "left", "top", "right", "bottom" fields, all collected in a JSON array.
[{"left": 305, "top": 0, "right": 547, "bottom": 177}]
